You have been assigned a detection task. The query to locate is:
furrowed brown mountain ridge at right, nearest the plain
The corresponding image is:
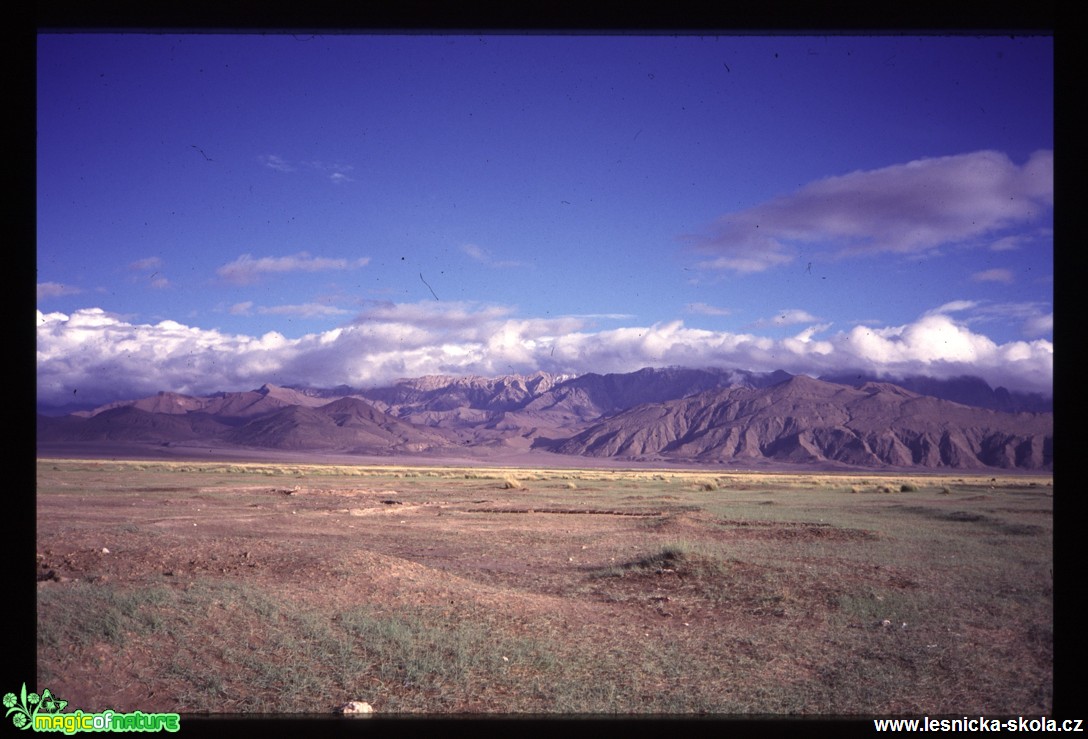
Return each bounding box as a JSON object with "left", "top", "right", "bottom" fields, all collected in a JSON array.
[{"left": 551, "top": 375, "right": 1053, "bottom": 469}]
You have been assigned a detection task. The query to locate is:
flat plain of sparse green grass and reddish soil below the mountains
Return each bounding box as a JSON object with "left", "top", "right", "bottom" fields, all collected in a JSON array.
[{"left": 37, "top": 459, "right": 1053, "bottom": 716}]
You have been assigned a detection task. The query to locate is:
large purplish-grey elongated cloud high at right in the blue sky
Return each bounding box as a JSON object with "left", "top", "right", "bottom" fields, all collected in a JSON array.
[{"left": 684, "top": 150, "right": 1054, "bottom": 273}]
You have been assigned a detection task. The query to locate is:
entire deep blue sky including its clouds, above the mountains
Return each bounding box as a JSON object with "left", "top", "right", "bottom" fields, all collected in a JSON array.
[{"left": 37, "top": 34, "right": 1053, "bottom": 405}]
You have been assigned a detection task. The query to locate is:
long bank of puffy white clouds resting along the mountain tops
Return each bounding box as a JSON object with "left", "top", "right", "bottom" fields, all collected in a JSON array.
[{"left": 37, "top": 301, "right": 1053, "bottom": 405}]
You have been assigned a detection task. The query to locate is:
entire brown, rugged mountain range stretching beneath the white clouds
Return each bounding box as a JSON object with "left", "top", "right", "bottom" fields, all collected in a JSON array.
[{"left": 37, "top": 368, "right": 1053, "bottom": 471}]
